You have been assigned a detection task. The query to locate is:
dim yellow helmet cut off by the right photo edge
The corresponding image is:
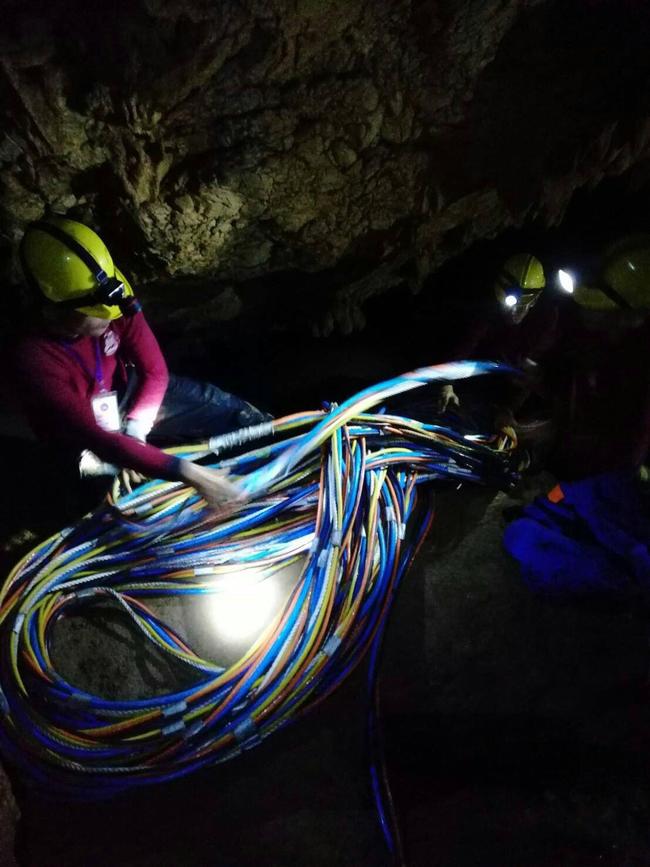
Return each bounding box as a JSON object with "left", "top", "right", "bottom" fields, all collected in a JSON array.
[{"left": 573, "top": 235, "right": 650, "bottom": 310}]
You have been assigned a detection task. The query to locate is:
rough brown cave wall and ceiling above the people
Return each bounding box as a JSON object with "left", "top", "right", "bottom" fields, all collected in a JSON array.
[{"left": 0, "top": 0, "right": 650, "bottom": 334}]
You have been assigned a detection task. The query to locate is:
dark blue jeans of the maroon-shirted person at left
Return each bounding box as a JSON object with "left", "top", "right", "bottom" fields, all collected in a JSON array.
[{"left": 147, "top": 375, "right": 272, "bottom": 445}]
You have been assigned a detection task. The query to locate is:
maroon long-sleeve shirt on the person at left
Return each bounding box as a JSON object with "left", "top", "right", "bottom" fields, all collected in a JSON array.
[{"left": 2, "top": 313, "right": 179, "bottom": 479}]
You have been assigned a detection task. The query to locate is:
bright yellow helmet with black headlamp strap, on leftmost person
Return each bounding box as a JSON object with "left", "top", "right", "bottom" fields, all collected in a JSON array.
[{"left": 20, "top": 217, "right": 140, "bottom": 319}]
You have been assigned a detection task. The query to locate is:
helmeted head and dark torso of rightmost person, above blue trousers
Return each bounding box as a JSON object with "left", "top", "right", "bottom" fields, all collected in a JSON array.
[{"left": 547, "top": 235, "right": 650, "bottom": 479}]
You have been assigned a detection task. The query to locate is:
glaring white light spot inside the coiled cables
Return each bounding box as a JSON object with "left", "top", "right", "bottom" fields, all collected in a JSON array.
[{"left": 204, "top": 569, "right": 280, "bottom": 644}]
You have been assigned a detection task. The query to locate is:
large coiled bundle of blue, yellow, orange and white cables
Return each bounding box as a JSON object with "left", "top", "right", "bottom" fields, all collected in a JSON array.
[{"left": 0, "top": 362, "right": 516, "bottom": 796}]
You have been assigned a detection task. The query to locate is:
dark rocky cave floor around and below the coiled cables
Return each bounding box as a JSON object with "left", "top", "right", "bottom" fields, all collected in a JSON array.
[{"left": 4, "top": 458, "right": 650, "bottom": 867}]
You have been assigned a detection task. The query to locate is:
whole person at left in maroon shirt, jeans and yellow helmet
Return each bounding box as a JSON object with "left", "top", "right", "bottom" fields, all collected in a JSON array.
[{"left": 2, "top": 216, "right": 270, "bottom": 511}]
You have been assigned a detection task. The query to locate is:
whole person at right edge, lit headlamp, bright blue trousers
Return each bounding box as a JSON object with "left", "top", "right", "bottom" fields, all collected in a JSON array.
[{"left": 504, "top": 235, "right": 650, "bottom": 596}]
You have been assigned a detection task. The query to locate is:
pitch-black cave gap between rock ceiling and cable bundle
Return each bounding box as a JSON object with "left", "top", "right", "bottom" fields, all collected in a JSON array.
[{"left": 162, "top": 170, "right": 650, "bottom": 415}]
